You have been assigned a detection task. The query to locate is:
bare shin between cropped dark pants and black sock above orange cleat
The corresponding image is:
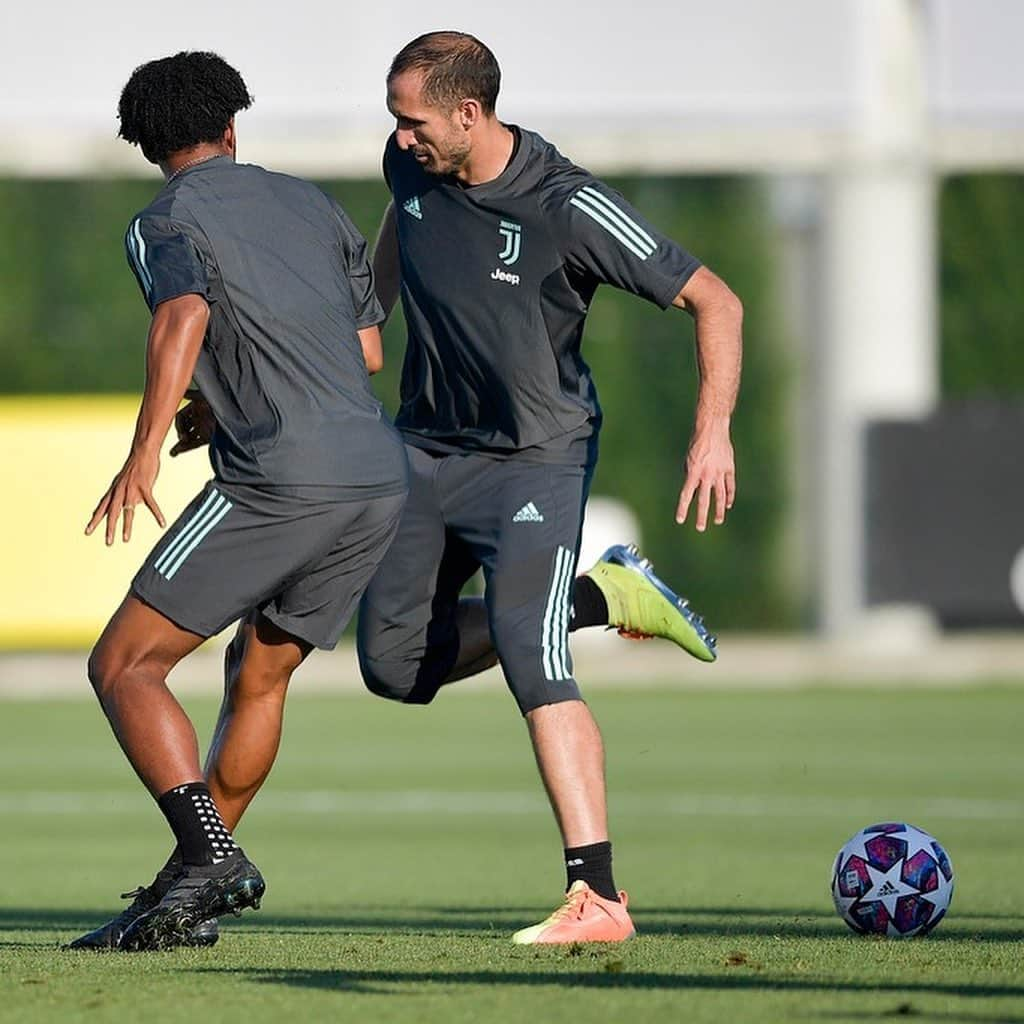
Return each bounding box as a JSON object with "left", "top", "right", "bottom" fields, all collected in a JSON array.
[{"left": 526, "top": 700, "right": 608, "bottom": 848}]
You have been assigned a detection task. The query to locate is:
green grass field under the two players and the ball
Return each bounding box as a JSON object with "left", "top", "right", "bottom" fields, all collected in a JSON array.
[{"left": 0, "top": 681, "right": 1024, "bottom": 1024}]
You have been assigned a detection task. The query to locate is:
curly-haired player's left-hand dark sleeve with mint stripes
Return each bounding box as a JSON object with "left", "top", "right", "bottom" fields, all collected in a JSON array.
[{"left": 125, "top": 214, "right": 208, "bottom": 312}]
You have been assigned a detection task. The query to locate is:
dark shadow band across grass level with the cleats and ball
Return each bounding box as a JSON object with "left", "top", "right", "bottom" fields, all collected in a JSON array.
[{"left": 0, "top": 903, "right": 1024, "bottom": 943}]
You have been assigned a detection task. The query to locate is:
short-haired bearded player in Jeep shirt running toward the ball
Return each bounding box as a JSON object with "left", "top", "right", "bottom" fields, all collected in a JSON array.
[{"left": 358, "top": 32, "right": 742, "bottom": 943}]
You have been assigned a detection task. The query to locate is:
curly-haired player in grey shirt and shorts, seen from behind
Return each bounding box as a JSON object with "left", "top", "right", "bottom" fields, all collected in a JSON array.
[{"left": 72, "top": 52, "right": 407, "bottom": 949}]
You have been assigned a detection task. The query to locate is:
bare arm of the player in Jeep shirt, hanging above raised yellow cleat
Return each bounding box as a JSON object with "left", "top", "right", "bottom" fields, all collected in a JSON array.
[{"left": 673, "top": 267, "right": 743, "bottom": 530}]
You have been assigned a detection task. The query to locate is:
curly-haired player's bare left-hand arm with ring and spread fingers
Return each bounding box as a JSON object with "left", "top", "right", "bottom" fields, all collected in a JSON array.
[{"left": 85, "top": 295, "right": 210, "bottom": 545}]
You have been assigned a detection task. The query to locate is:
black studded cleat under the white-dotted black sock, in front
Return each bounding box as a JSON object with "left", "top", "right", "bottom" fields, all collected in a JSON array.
[{"left": 120, "top": 851, "right": 266, "bottom": 951}]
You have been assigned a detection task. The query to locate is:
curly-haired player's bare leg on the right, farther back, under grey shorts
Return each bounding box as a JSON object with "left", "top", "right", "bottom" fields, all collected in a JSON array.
[{"left": 206, "top": 613, "right": 311, "bottom": 828}]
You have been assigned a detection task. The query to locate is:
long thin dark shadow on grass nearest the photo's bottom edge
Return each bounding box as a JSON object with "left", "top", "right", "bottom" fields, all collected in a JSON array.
[{"left": 197, "top": 963, "right": 1024, "bottom": 998}]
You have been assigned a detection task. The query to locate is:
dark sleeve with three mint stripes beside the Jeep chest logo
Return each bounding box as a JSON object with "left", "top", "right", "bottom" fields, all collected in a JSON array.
[{"left": 553, "top": 178, "right": 700, "bottom": 309}]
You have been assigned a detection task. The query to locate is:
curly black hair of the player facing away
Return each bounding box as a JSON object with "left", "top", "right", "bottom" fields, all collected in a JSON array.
[{"left": 118, "top": 50, "right": 253, "bottom": 164}]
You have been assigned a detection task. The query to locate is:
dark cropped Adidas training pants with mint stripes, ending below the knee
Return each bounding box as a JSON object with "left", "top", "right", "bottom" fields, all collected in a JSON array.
[{"left": 358, "top": 445, "right": 591, "bottom": 714}]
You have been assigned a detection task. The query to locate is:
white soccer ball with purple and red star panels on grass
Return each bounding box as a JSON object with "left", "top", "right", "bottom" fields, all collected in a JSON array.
[{"left": 833, "top": 822, "right": 953, "bottom": 939}]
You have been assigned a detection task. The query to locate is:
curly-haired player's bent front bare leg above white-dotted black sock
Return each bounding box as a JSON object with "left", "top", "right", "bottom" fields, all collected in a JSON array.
[{"left": 89, "top": 596, "right": 204, "bottom": 798}]
